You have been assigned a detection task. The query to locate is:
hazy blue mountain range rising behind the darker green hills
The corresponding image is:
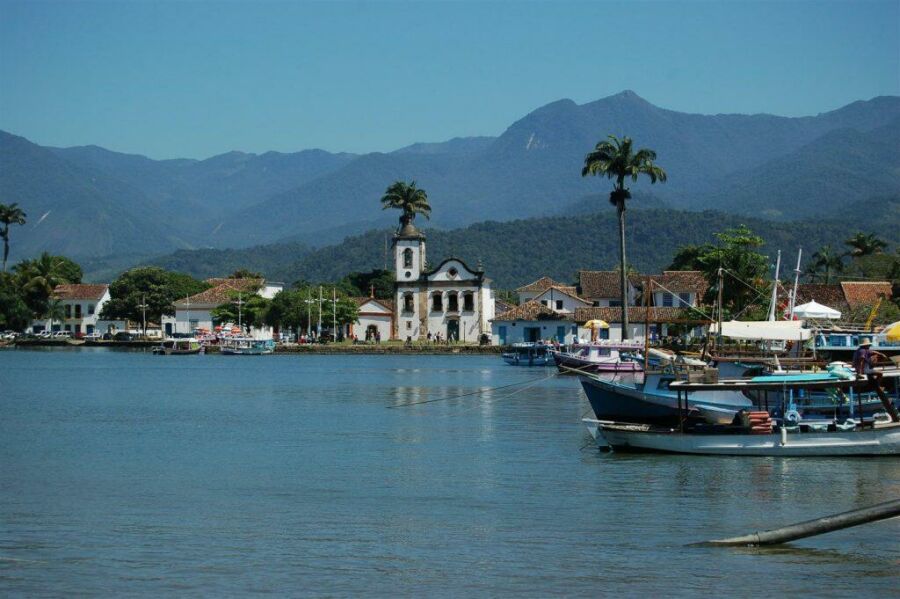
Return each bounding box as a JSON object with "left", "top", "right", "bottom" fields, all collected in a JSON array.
[{"left": 0, "top": 91, "right": 900, "bottom": 262}]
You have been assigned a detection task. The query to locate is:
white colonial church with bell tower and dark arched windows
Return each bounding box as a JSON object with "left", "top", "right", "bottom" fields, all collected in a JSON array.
[{"left": 394, "top": 222, "right": 494, "bottom": 343}]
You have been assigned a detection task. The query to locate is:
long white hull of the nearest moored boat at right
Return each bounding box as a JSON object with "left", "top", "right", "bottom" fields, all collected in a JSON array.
[{"left": 596, "top": 422, "right": 900, "bottom": 457}]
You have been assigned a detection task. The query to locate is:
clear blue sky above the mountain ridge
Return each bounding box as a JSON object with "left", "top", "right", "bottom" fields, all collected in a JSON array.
[{"left": 0, "top": 0, "right": 900, "bottom": 158}]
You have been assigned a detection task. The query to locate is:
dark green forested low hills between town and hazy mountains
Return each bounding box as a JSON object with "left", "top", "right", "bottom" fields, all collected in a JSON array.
[{"left": 137, "top": 197, "right": 900, "bottom": 288}]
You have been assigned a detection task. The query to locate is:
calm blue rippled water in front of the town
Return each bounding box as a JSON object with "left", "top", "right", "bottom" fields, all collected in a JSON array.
[{"left": 0, "top": 349, "right": 900, "bottom": 596}]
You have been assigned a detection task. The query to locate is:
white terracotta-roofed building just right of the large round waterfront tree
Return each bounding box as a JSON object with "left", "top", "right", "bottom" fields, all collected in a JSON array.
[{"left": 162, "top": 279, "right": 284, "bottom": 339}]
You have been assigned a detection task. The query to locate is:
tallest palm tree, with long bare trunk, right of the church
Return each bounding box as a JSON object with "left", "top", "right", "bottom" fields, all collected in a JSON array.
[{"left": 581, "top": 135, "right": 666, "bottom": 339}]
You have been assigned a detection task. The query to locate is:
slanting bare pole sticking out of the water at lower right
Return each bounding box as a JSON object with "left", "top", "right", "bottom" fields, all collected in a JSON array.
[{"left": 696, "top": 499, "right": 900, "bottom": 546}]
